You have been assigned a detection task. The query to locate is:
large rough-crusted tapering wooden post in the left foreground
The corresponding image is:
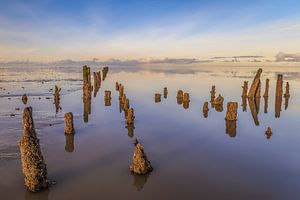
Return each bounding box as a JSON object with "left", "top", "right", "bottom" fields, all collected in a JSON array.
[{"left": 19, "top": 107, "right": 49, "bottom": 192}]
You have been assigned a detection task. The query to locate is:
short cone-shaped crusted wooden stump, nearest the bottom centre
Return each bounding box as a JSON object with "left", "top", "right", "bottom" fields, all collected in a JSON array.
[{"left": 129, "top": 140, "right": 153, "bottom": 175}]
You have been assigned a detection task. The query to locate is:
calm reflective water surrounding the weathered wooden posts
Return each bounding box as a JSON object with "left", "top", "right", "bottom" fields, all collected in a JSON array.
[{"left": 0, "top": 66, "right": 300, "bottom": 200}]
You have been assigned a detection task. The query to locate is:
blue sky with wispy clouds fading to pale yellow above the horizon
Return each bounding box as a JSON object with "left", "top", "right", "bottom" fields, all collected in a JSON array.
[{"left": 0, "top": 0, "right": 300, "bottom": 62}]
